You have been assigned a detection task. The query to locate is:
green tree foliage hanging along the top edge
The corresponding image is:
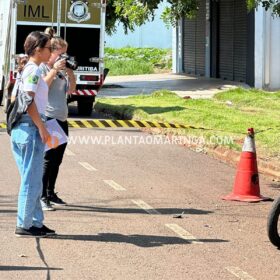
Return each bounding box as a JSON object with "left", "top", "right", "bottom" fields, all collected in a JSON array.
[{"left": 106, "top": 0, "right": 280, "bottom": 34}]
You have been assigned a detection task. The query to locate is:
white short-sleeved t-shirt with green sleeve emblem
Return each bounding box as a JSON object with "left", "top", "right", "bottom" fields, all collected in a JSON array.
[{"left": 21, "top": 62, "right": 49, "bottom": 115}]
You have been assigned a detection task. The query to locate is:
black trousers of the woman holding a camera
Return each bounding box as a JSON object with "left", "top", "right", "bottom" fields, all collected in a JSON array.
[{"left": 42, "top": 118, "right": 68, "bottom": 197}]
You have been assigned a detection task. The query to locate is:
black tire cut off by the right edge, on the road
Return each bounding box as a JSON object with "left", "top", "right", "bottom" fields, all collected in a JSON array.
[{"left": 267, "top": 197, "right": 280, "bottom": 248}]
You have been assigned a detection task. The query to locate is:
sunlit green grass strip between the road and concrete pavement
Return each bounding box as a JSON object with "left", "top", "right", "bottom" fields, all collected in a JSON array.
[{"left": 95, "top": 89, "right": 280, "bottom": 157}]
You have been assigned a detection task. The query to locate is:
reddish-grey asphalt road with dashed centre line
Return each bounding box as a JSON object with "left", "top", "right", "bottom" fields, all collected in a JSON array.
[{"left": 0, "top": 104, "right": 280, "bottom": 280}]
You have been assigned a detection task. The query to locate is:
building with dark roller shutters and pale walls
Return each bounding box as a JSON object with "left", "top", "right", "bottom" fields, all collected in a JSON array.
[{"left": 173, "top": 0, "right": 280, "bottom": 90}]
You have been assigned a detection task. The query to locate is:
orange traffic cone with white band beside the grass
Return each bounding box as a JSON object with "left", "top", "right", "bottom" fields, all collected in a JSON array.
[{"left": 223, "top": 128, "right": 270, "bottom": 202}]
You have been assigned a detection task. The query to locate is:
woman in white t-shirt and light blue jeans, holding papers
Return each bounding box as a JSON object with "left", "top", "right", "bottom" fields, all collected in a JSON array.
[{"left": 11, "top": 31, "right": 55, "bottom": 237}]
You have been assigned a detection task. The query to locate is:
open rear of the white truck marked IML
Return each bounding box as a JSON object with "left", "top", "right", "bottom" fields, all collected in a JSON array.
[{"left": 16, "top": 0, "right": 106, "bottom": 88}]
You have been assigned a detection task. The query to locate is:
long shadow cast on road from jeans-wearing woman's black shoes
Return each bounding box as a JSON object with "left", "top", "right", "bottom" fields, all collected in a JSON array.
[{"left": 48, "top": 233, "right": 229, "bottom": 248}]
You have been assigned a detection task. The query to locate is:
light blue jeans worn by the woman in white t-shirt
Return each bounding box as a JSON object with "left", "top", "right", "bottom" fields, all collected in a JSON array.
[{"left": 11, "top": 114, "right": 45, "bottom": 229}]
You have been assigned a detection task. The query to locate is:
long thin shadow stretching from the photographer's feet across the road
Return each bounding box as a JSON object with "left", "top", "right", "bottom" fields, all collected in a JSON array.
[{"left": 56, "top": 204, "right": 213, "bottom": 215}]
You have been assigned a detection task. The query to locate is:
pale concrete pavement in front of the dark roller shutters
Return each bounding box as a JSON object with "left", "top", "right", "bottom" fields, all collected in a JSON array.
[{"left": 98, "top": 73, "right": 249, "bottom": 98}]
